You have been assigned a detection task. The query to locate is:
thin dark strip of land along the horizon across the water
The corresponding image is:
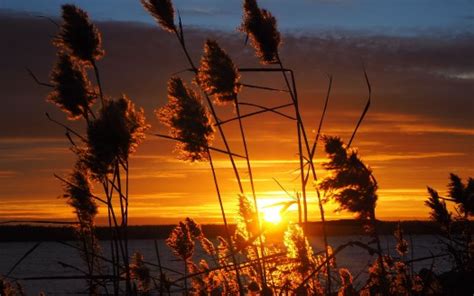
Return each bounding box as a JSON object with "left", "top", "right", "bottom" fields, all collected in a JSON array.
[{"left": 0, "top": 220, "right": 466, "bottom": 242}]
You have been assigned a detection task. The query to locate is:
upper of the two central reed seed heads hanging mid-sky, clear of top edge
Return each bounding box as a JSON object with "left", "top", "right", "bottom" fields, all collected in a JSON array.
[{"left": 197, "top": 40, "right": 240, "bottom": 104}]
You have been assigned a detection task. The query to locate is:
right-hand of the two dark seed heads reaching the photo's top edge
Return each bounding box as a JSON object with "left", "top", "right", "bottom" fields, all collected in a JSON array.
[{"left": 240, "top": 0, "right": 281, "bottom": 64}]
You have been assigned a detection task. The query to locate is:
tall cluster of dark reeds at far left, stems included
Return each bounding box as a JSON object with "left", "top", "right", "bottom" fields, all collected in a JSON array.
[{"left": 25, "top": 4, "right": 149, "bottom": 295}]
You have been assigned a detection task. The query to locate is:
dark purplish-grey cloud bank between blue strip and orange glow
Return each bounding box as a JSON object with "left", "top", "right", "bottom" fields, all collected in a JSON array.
[{"left": 0, "top": 14, "right": 474, "bottom": 136}]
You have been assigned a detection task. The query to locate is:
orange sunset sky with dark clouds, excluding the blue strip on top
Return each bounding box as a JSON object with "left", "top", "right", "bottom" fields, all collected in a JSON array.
[{"left": 0, "top": 15, "right": 474, "bottom": 224}]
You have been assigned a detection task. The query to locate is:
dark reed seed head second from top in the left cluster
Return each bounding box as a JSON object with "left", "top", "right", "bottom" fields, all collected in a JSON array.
[{"left": 47, "top": 53, "right": 95, "bottom": 120}]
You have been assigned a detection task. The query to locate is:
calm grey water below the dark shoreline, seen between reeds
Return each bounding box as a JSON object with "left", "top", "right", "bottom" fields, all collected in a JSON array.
[{"left": 0, "top": 235, "right": 449, "bottom": 295}]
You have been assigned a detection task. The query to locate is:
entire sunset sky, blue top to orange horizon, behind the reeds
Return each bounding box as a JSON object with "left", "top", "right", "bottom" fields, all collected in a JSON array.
[{"left": 0, "top": 0, "right": 474, "bottom": 224}]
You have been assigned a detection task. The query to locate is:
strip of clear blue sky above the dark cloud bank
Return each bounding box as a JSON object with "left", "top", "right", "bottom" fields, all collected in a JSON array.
[{"left": 0, "top": 0, "right": 474, "bottom": 36}]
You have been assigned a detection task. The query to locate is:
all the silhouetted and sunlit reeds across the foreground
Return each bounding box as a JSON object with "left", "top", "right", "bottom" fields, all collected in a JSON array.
[{"left": 0, "top": 0, "right": 474, "bottom": 295}]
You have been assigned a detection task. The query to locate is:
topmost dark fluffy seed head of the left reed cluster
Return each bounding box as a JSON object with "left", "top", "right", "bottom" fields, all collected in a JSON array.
[{"left": 54, "top": 4, "right": 104, "bottom": 65}]
